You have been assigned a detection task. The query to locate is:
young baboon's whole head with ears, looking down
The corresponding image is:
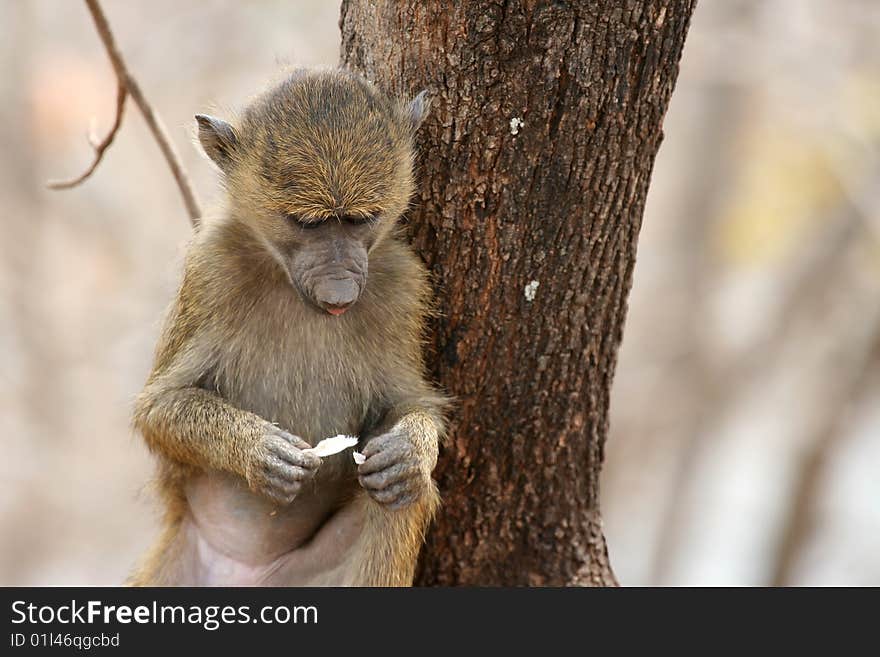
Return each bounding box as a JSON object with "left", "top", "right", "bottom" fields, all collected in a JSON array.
[{"left": 196, "top": 71, "right": 426, "bottom": 316}]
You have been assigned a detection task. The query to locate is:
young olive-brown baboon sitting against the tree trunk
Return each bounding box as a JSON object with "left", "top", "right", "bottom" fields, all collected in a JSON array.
[{"left": 130, "top": 70, "right": 446, "bottom": 586}]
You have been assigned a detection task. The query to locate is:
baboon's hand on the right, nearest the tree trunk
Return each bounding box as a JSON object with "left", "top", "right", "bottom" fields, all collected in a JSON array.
[{"left": 358, "top": 428, "right": 433, "bottom": 509}]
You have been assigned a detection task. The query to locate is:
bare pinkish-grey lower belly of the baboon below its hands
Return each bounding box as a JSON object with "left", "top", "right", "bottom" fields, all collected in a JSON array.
[{"left": 178, "top": 472, "right": 364, "bottom": 586}]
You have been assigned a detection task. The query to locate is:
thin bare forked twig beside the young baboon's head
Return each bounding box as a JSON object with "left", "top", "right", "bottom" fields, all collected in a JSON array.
[{"left": 48, "top": 0, "right": 202, "bottom": 228}]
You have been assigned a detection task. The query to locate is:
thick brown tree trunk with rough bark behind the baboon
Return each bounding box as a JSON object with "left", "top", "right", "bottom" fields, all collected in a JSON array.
[{"left": 340, "top": 0, "right": 695, "bottom": 585}]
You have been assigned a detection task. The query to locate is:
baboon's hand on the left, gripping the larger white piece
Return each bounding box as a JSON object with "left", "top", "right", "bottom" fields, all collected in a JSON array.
[{"left": 246, "top": 425, "right": 321, "bottom": 506}]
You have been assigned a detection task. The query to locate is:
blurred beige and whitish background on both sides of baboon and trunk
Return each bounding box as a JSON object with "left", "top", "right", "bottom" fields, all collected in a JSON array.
[{"left": 0, "top": 0, "right": 880, "bottom": 585}]
